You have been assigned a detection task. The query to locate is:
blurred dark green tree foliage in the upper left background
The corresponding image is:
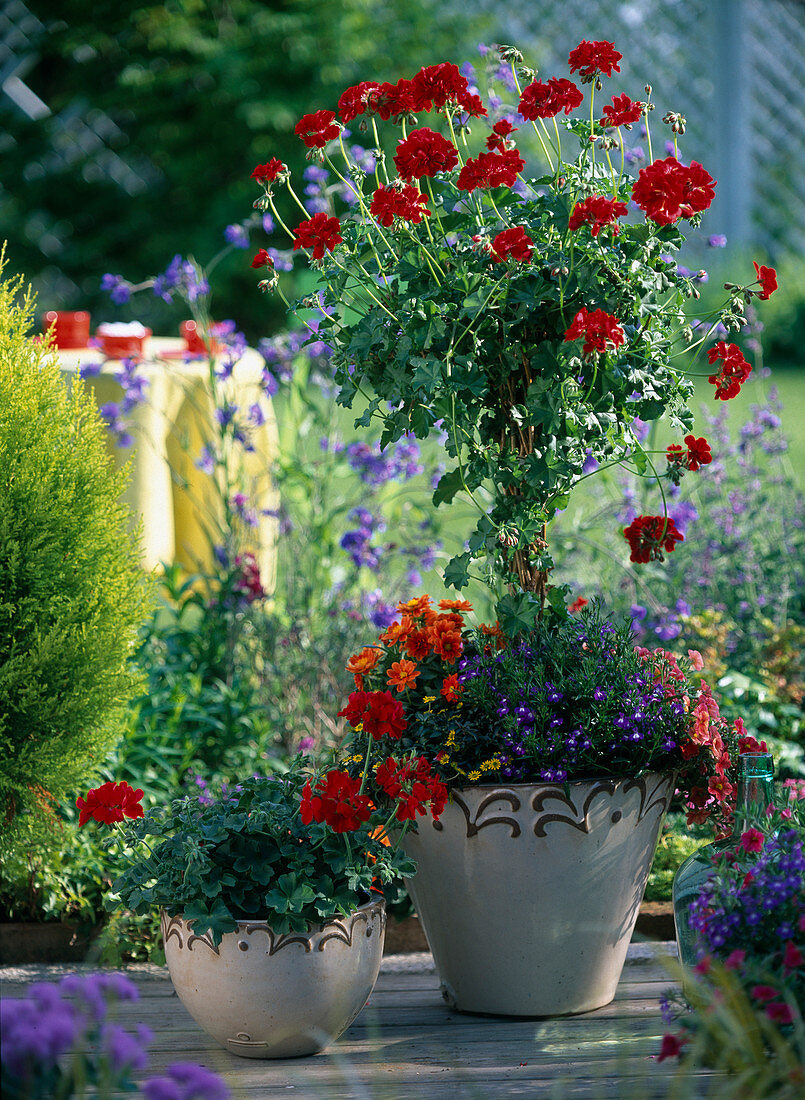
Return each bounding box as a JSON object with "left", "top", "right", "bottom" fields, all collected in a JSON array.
[{"left": 0, "top": 0, "right": 482, "bottom": 339}]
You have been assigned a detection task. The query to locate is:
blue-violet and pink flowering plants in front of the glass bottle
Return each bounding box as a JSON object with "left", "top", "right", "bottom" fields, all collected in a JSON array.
[{"left": 660, "top": 781, "right": 805, "bottom": 1082}]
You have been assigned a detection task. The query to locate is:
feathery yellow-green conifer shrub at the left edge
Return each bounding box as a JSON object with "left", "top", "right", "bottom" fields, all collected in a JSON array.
[{"left": 0, "top": 254, "right": 151, "bottom": 827}]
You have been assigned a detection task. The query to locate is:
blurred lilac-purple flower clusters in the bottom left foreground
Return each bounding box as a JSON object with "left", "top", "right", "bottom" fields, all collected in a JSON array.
[{"left": 0, "top": 974, "right": 230, "bottom": 1100}]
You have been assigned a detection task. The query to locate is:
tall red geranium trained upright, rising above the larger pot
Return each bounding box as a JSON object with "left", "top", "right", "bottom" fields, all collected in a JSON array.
[{"left": 253, "top": 42, "right": 776, "bottom": 635}]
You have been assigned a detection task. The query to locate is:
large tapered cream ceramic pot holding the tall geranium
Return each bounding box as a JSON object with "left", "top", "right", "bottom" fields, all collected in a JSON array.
[{"left": 404, "top": 774, "right": 674, "bottom": 1016}]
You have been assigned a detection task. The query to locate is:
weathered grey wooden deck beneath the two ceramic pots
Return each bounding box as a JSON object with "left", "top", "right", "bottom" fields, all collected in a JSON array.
[{"left": 0, "top": 945, "right": 709, "bottom": 1100}]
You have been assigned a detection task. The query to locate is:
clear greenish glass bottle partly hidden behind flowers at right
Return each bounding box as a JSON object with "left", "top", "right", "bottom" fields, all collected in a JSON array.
[{"left": 673, "top": 752, "right": 774, "bottom": 967}]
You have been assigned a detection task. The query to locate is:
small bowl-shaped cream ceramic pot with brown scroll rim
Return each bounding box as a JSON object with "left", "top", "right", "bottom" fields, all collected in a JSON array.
[{"left": 162, "top": 900, "right": 386, "bottom": 1058}]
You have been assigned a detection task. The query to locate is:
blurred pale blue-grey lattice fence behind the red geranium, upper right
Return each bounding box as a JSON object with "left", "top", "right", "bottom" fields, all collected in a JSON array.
[{"left": 465, "top": 0, "right": 805, "bottom": 260}]
